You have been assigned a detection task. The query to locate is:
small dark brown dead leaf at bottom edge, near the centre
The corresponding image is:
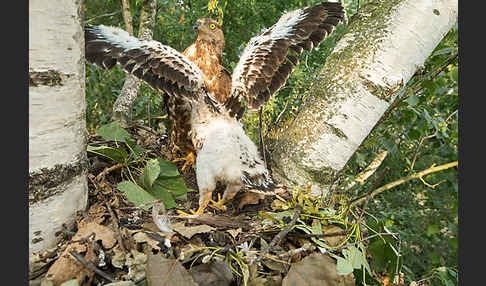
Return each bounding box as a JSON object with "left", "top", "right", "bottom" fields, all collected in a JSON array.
[{"left": 189, "top": 261, "right": 233, "bottom": 286}]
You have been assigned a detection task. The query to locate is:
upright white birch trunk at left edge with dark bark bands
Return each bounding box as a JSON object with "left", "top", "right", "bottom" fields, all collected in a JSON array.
[{"left": 28, "top": 0, "right": 88, "bottom": 256}]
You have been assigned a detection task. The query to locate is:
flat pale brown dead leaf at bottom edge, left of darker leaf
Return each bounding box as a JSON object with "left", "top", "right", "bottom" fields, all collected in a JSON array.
[{"left": 146, "top": 254, "right": 198, "bottom": 286}]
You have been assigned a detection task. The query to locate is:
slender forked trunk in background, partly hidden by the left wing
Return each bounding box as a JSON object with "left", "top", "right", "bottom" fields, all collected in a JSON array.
[{"left": 112, "top": 0, "right": 156, "bottom": 127}]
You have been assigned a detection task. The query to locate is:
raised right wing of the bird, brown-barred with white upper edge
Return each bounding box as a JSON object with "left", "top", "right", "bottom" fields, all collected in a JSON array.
[{"left": 225, "top": 2, "right": 344, "bottom": 115}]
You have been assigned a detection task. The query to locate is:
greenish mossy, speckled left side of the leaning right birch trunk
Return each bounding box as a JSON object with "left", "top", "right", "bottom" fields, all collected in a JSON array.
[{"left": 267, "top": 0, "right": 404, "bottom": 190}]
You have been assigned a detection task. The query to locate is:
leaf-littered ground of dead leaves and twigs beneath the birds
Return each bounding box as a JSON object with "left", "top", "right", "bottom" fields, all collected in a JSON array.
[{"left": 29, "top": 124, "right": 391, "bottom": 286}]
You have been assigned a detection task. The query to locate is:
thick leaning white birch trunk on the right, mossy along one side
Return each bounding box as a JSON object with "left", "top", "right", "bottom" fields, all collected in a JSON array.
[{"left": 267, "top": 0, "right": 458, "bottom": 194}]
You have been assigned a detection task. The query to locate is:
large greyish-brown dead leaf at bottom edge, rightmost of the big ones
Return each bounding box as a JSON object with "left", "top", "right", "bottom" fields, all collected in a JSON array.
[{"left": 282, "top": 253, "right": 355, "bottom": 286}]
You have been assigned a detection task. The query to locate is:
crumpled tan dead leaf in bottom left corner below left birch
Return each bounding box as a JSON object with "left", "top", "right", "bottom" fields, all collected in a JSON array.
[{"left": 46, "top": 242, "right": 95, "bottom": 286}]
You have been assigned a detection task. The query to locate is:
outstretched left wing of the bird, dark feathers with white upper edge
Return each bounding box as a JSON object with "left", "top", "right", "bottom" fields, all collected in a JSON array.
[{"left": 85, "top": 25, "right": 216, "bottom": 106}]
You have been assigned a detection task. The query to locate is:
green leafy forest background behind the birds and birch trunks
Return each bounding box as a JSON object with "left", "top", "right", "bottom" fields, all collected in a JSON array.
[{"left": 84, "top": 0, "right": 459, "bottom": 285}]
